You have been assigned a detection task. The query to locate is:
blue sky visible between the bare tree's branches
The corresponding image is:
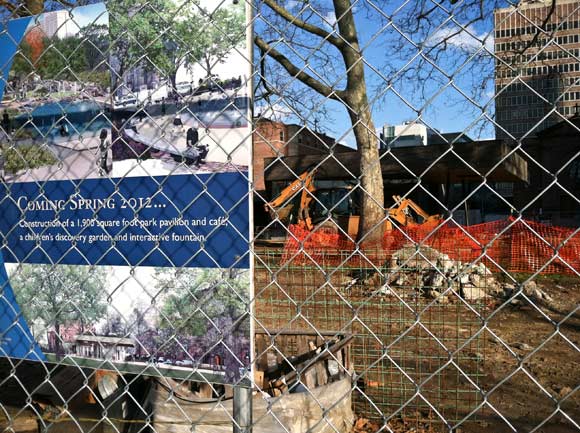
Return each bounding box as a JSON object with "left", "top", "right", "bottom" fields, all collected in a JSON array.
[{"left": 256, "top": 0, "right": 502, "bottom": 146}]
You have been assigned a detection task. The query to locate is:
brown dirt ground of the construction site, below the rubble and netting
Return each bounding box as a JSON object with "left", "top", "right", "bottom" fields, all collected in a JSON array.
[{"left": 256, "top": 250, "right": 580, "bottom": 433}]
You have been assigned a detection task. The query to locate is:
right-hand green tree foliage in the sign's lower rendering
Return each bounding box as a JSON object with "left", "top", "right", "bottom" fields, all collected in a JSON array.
[{"left": 156, "top": 268, "right": 249, "bottom": 336}]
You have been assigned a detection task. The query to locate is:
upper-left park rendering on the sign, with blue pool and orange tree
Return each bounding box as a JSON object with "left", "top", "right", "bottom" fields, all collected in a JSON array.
[{"left": 0, "top": 3, "right": 111, "bottom": 181}]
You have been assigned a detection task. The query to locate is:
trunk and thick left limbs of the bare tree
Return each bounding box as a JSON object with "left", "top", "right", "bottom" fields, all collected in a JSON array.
[{"left": 255, "top": 0, "right": 385, "bottom": 242}]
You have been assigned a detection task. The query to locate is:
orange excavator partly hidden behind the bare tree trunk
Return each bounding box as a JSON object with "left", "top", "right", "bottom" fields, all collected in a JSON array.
[{"left": 264, "top": 169, "right": 442, "bottom": 239}]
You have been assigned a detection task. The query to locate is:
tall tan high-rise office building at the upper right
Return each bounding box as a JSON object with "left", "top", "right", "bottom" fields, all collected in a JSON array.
[{"left": 494, "top": 0, "right": 580, "bottom": 138}]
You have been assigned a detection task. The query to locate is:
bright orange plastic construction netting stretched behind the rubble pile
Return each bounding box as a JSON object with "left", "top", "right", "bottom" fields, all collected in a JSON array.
[{"left": 282, "top": 218, "right": 580, "bottom": 275}]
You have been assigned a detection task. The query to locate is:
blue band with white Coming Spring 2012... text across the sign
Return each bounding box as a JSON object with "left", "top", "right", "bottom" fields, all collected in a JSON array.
[{"left": 0, "top": 173, "right": 249, "bottom": 268}]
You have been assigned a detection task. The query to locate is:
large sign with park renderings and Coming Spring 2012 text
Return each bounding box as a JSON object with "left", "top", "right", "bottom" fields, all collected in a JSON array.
[{"left": 0, "top": 0, "right": 251, "bottom": 382}]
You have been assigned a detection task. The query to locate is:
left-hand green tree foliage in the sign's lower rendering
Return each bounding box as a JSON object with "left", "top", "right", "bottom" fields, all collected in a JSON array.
[{"left": 10, "top": 264, "right": 106, "bottom": 333}]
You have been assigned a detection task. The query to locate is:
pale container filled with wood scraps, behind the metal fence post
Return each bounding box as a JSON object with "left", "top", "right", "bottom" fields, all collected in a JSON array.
[{"left": 143, "top": 330, "right": 354, "bottom": 433}]
